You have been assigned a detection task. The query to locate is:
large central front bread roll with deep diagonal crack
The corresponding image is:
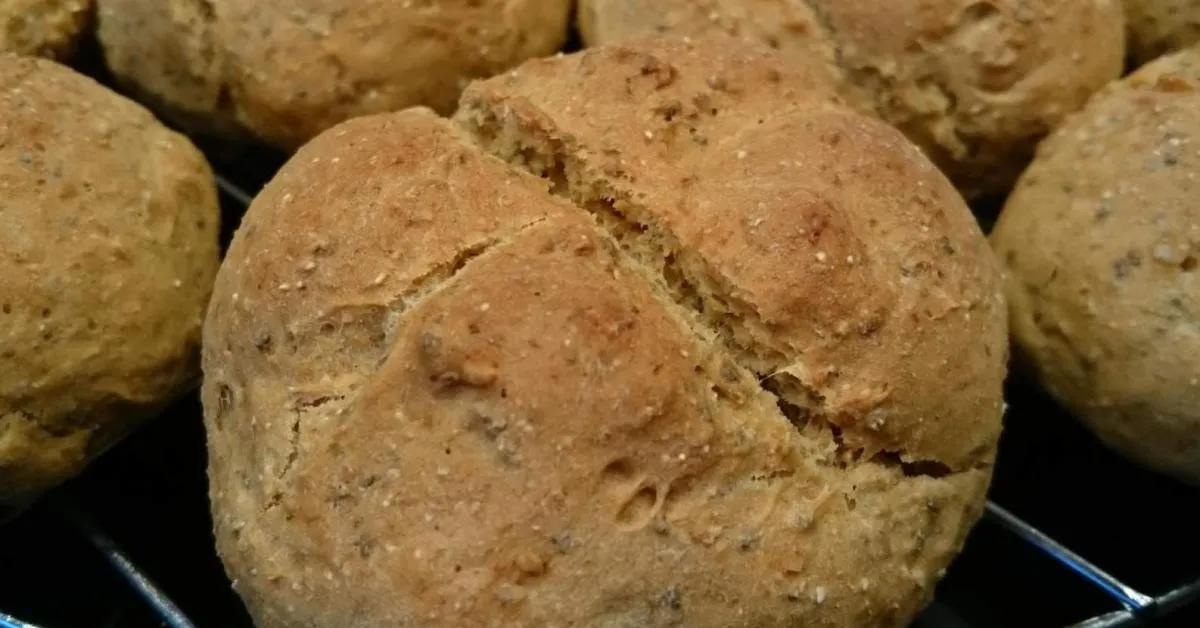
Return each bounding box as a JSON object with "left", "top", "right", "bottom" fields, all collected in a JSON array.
[{"left": 204, "top": 41, "right": 1006, "bottom": 628}]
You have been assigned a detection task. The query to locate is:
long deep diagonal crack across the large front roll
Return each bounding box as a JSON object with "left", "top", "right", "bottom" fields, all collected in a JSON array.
[{"left": 458, "top": 107, "right": 960, "bottom": 478}]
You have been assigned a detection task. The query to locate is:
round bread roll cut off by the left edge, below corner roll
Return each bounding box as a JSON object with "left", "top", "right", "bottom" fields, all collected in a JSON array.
[{"left": 0, "top": 55, "right": 218, "bottom": 502}]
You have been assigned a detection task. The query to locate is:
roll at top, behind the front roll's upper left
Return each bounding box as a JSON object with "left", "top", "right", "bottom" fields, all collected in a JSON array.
[{"left": 97, "top": 0, "right": 571, "bottom": 149}]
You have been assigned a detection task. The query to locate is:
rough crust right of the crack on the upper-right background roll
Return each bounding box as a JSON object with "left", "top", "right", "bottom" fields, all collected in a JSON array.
[{"left": 809, "top": 0, "right": 1124, "bottom": 197}]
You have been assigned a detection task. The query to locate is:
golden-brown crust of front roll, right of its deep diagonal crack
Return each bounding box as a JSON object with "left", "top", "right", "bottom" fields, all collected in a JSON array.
[{"left": 458, "top": 40, "right": 1004, "bottom": 468}]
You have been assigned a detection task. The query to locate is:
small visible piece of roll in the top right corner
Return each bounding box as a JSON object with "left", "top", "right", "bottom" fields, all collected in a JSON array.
[{"left": 1124, "top": 0, "right": 1200, "bottom": 64}]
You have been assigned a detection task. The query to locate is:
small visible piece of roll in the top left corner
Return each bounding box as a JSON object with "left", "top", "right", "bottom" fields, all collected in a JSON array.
[{"left": 0, "top": 0, "right": 92, "bottom": 59}]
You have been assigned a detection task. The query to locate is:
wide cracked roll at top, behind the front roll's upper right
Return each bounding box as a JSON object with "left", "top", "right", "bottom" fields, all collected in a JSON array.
[{"left": 580, "top": 0, "right": 1124, "bottom": 197}]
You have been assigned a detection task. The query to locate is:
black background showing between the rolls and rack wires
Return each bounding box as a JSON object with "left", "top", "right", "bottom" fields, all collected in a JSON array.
[{"left": 0, "top": 24, "right": 1200, "bottom": 628}]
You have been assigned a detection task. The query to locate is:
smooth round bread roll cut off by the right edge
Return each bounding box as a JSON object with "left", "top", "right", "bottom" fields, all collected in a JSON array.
[{"left": 992, "top": 50, "right": 1200, "bottom": 483}]
